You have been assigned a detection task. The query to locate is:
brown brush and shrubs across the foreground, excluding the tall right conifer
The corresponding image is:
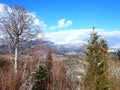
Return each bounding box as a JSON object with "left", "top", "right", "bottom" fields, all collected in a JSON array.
[{"left": 0, "top": 31, "right": 120, "bottom": 90}]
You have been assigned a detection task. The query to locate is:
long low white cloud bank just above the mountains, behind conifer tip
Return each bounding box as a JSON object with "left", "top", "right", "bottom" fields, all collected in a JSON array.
[{"left": 46, "top": 29, "right": 120, "bottom": 48}]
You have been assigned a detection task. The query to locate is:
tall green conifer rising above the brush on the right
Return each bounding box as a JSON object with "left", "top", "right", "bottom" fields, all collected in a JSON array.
[{"left": 83, "top": 28, "right": 111, "bottom": 90}]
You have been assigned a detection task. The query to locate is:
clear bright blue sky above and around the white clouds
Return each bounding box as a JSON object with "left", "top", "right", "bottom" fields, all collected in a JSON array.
[{"left": 0, "top": 0, "right": 120, "bottom": 32}]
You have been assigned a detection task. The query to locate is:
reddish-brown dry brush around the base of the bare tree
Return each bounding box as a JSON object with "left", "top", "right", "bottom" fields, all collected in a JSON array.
[{"left": 0, "top": 54, "right": 37, "bottom": 90}]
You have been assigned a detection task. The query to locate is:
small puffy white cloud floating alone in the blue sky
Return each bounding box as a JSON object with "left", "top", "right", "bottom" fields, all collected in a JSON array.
[{"left": 50, "top": 19, "right": 72, "bottom": 29}]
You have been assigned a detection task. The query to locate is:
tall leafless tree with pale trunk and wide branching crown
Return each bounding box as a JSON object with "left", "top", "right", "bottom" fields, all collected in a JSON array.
[{"left": 0, "top": 5, "right": 39, "bottom": 73}]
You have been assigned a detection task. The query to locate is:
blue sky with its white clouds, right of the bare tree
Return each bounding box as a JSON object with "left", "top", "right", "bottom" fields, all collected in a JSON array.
[{"left": 0, "top": 0, "right": 120, "bottom": 47}]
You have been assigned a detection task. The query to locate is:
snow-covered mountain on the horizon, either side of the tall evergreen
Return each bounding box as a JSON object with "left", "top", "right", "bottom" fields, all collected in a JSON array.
[{"left": 45, "top": 41, "right": 120, "bottom": 55}]
